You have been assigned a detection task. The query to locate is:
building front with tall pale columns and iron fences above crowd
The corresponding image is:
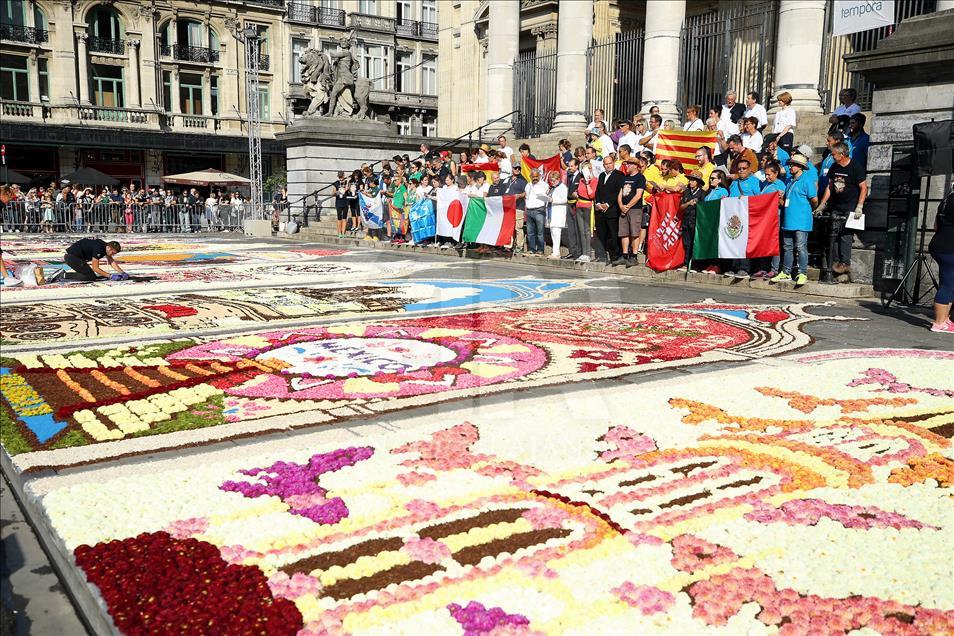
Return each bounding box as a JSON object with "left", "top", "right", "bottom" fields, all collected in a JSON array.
[{"left": 439, "top": 0, "right": 951, "bottom": 138}]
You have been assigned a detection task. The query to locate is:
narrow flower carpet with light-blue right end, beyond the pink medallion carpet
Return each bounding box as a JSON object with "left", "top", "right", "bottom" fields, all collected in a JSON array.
[{"left": 0, "top": 278, "right": 573, "bottom": 345}]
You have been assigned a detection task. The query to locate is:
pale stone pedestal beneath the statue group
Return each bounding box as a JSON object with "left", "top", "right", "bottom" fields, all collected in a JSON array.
[{"left": 276, "top": 117, "right": 450, "bottom": 214}]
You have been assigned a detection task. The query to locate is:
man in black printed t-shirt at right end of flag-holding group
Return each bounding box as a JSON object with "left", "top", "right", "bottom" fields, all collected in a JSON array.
[{"left": 815, "top": 141, "right": 868, "bottom": 274}]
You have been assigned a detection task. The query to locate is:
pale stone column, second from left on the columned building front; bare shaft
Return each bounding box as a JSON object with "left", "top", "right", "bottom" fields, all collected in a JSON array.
[{"left": 552, "top": 0, "right": 593, "bottom": 134}]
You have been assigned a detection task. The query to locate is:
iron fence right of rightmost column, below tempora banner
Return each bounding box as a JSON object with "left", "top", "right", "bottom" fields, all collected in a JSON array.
[{"left": 819, "top": 0, "right": 937, "bottom": 112}]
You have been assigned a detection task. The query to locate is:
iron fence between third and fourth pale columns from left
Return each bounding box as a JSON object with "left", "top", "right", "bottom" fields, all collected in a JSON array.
[{"left": 678, "top": 2, "right": 777, "bottom": 117}]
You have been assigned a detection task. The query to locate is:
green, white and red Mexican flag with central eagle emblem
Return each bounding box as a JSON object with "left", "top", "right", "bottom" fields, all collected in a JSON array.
[{"left": 692, "top": 192, "right": 778, "bottom": 260}]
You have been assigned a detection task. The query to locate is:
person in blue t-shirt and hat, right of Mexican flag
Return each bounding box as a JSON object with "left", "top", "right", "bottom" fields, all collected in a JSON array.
[{"left": 771, "top": 153, "right": 818, "bottom": 285}]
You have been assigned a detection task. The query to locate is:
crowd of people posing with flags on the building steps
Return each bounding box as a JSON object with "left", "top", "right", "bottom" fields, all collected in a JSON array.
[{"left": 332, "top": 89, "right": 869, "bottom": 283}]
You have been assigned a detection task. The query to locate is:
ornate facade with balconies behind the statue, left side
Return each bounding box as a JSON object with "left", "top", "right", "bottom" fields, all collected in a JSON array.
[{"left": 0, "top": 0, "right": 438, "bottom": 185}]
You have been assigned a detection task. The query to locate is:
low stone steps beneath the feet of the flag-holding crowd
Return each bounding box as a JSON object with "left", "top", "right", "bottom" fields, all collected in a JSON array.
[{"left": 278, "top": 216, "right": 874, "bottom": 298}]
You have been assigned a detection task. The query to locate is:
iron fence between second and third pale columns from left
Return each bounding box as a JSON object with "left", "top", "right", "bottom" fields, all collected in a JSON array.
[{"left": 586, "top": 29, "right": 644, "bottom": 128}]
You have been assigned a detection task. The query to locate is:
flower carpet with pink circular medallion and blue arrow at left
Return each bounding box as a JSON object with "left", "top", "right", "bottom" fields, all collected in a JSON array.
[{"left": 0, "top": 304, "right": 832, "bottom": 470}]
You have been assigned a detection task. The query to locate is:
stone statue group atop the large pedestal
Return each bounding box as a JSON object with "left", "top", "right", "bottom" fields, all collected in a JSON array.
[{"left": 299, "top": 29, "right": 371, "bottom": 119}]
